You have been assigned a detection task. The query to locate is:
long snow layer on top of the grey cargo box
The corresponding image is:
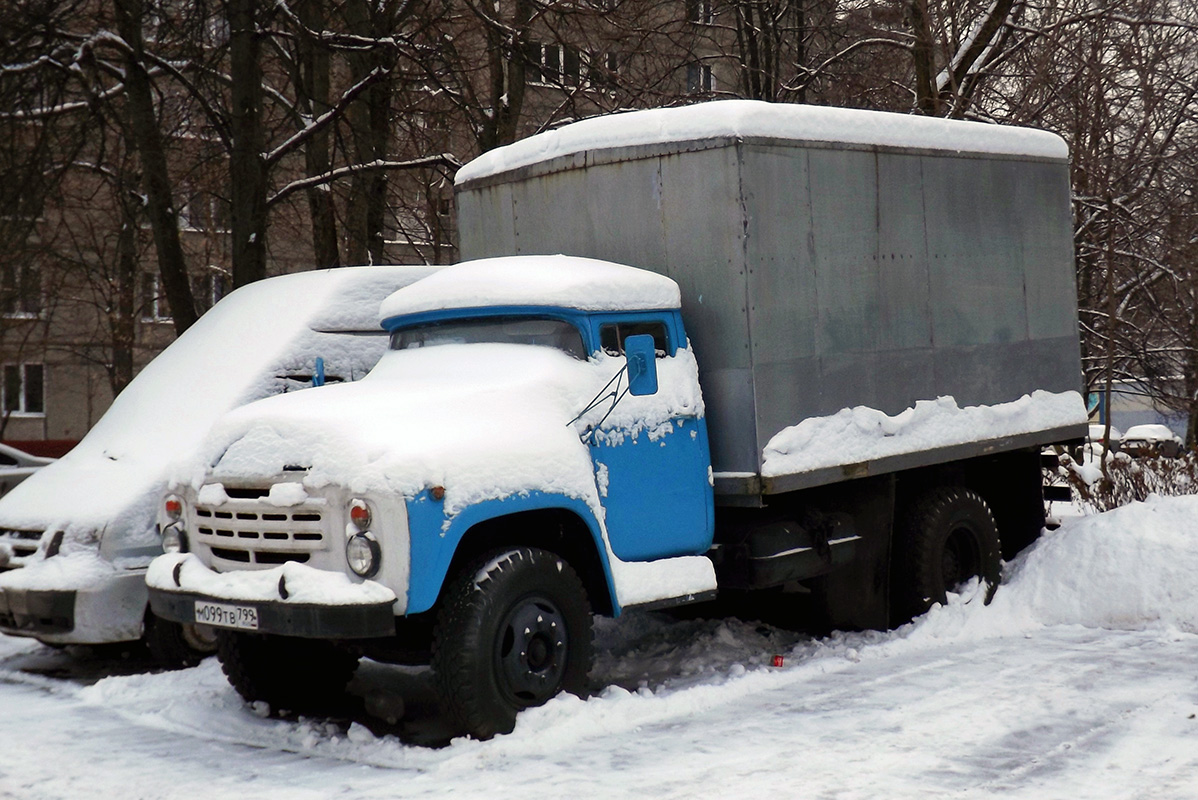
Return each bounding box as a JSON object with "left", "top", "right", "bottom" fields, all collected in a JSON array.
[{"left": 455, "top": 99, "right": 1069, "bottom": 186}]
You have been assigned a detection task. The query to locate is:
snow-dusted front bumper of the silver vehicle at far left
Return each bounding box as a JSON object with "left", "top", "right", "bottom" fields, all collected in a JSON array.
[{"left": 0, "top": 570, "right": 146, "bottom": 644}]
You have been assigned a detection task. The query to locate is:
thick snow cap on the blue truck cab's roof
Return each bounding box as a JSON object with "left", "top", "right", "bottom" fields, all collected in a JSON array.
[{"left": 379, "top": 255, "right": 682, "bottom": 325}]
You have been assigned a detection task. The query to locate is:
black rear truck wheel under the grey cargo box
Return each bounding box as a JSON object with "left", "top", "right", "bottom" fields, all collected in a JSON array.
[{"left": 891, "top": 486, "right": 1002, "bottom": 623}]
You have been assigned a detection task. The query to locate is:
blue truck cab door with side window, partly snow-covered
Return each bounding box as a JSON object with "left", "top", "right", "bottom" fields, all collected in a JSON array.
[{"left": 591, "top": 321, "right": 714, "bottom": 560}]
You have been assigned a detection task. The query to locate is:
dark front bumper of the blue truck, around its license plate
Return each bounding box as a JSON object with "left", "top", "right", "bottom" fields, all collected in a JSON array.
[{"left": 150, "top": 589, "right": 395, "bottom": 640}]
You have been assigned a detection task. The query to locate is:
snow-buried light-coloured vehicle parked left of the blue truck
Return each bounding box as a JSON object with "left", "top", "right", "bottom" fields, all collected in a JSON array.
[{"left": 0, "top": 266, "right": 436, "bottom": 663}]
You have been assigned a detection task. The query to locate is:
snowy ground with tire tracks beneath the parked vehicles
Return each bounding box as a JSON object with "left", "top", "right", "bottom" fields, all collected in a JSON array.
[{"left": 0, "top": 498, "right": 1198, "bottom": 800}]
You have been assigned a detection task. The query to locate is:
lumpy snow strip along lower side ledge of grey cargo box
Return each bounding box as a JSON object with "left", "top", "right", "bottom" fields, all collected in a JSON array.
[{"left": 761, "top": 390, "right": 1087, "bottom": 475}]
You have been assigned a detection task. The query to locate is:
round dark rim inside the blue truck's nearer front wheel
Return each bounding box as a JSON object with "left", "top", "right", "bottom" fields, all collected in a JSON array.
[{"left": 495, "top": 596, "right": 568, "bottom": 708}]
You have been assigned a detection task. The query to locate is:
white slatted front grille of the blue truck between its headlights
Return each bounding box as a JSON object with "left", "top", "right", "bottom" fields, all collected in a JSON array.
[{"left": 193, "top": 490, "right": 329, "bottom": 566}]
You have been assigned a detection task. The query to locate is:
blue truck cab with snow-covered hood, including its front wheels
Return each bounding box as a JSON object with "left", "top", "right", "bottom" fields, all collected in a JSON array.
[{"left": 147, "top": 256, "right": 715, "bottom": 735}]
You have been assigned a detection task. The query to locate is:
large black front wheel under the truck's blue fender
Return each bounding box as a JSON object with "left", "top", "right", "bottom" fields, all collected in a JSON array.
[{"left": 432, "top": 547, "right": 592, "bottom": 739}]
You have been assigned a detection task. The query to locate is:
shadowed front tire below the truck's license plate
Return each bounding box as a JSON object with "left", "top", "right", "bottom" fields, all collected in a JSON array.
[{"left": 217, "top": 630, "right": 358, "bottom": 713}]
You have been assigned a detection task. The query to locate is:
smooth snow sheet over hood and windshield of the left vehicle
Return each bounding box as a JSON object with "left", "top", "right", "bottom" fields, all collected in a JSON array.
[{"left": 0, "top": 267, "right": 432, "bottom": 534}]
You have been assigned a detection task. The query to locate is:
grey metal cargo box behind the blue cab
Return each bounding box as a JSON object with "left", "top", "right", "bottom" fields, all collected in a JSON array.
[{"left": 458, "top": 105, "right": 1084, "bottom": 493}]
